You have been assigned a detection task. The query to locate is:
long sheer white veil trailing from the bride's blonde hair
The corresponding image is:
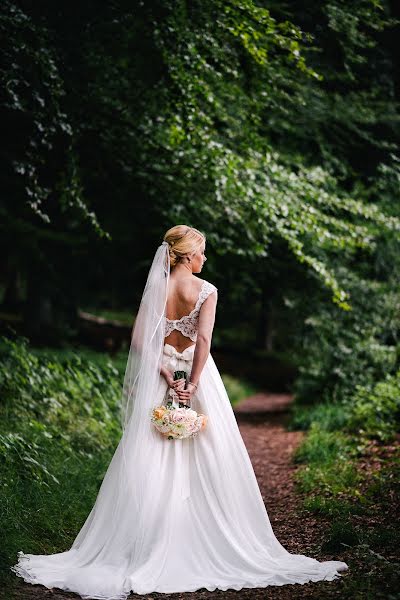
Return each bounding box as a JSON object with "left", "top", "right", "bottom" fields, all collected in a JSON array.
[{"left": 66, "top": 242, "right": 170, "bottom": 571}]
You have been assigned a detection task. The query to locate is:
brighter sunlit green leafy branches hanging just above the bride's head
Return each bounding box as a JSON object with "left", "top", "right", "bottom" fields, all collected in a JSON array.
[{"left": 142, "top": 2, "right": 399, "bottom": 309}]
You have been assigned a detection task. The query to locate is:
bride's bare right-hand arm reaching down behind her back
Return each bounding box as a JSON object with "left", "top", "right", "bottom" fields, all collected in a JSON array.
[{"left": 178, "top": 291, "right": 217, "bottom": 400}]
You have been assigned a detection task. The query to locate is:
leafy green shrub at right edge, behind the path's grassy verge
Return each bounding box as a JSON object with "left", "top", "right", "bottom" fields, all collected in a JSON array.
[{"left": 294, "top": 268, "right": 400, "bottom": 404}]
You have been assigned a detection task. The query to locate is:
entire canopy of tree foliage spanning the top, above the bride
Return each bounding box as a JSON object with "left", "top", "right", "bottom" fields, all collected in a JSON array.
[{"left": 0, "top": 0, "right": 399, "bottom": 328}]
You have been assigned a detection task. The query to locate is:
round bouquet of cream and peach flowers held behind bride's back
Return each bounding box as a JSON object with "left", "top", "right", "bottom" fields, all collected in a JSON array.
[{"left": 151, "top": 371, "right": 208, "bottom": 440}]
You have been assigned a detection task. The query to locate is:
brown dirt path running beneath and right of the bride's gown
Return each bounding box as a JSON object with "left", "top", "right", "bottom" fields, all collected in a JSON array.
[{"left": 13, "top": 394, "right": 341, "bottom": 600}]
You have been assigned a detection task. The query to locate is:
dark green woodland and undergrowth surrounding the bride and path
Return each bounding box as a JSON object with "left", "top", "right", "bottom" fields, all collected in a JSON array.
[{"left": 0, "top": 0, "right": 400, "bottom": 599}]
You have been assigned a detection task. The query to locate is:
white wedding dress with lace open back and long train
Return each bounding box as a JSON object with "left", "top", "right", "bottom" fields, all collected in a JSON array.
[{"left": 11, "top": 281, "right": 348, "bottom": 600}]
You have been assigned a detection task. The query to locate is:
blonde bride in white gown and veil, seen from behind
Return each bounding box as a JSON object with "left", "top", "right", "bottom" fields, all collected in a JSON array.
[{"left": 11, "top": 225, "right": 348, "bottom": 600}]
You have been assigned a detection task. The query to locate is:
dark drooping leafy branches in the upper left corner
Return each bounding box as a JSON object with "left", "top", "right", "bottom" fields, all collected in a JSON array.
[{"left": 0, "top": 0, "right": 105, "bottom": 235}]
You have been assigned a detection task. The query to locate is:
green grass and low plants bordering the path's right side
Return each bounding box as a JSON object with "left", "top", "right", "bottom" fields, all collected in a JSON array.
[{"left": 294, "top": 400, "right": 400, "bottom": 600}]
